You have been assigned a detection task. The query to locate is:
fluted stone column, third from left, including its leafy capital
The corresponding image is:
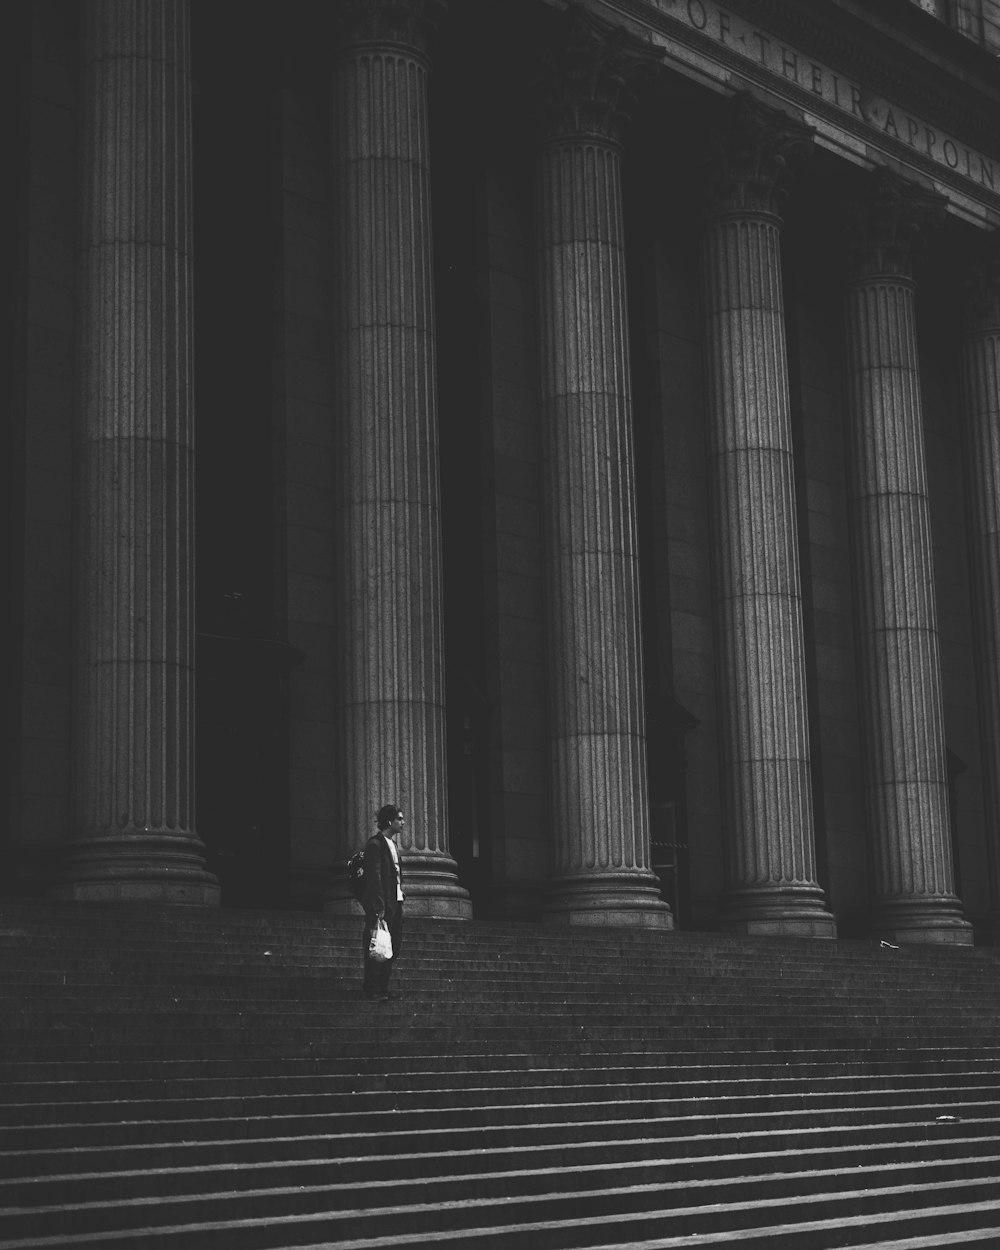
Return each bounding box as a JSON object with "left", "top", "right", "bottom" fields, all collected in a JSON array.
[{"left": 536, "top": 13, "right": 673, "bottom": 928}]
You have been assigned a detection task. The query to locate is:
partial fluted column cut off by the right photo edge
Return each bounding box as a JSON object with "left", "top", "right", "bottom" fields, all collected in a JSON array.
[{"left": 961, "top": 235, "right": 1000, "bottom": 934}]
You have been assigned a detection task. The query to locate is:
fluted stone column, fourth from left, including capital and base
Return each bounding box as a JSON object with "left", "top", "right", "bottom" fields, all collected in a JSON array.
[{"left": 704, "top": 96, "right": 836, "bottom": 938}]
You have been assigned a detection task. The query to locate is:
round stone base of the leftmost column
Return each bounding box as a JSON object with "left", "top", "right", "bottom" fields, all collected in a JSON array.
[{"left": 49, "top": 831, "right": 220, "bottom": 908}]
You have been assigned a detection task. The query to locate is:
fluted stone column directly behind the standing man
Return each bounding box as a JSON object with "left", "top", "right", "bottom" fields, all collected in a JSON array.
[{"left": 328, "top": 0, "right": 471, "bottom": 916}]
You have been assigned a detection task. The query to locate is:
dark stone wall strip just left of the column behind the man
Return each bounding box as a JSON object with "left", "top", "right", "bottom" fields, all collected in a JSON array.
[{"left": 274, "top": 89, "right": 337, "bottom": 903}]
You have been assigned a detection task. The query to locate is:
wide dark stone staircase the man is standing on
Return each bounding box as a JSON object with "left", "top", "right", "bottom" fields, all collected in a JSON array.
[{"left": 0, "top": 901, "right": 1000, "bottom": 1250}]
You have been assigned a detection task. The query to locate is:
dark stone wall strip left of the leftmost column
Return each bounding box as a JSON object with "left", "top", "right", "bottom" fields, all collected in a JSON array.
[{"left": 8, "top": 0, "right": 78, "bottom": 890}]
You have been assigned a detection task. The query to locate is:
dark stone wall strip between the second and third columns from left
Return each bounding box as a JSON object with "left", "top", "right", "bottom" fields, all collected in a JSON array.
[{"left": 476, "top": 163, "right": 549, "bottom": 915}]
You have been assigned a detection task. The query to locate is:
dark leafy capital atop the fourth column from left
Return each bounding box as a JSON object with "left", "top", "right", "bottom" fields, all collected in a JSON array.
[{"left": 709, "top": 91, "right": 813, "bottom": 216}]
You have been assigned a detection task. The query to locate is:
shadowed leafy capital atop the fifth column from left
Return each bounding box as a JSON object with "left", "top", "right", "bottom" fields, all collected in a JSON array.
[{"left": 845, "top": 166, "right": 946, "bottom": 279}]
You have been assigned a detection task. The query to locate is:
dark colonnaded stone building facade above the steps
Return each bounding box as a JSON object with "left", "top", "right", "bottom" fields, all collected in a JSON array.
[{"left": 0, "top": 0, "right": 1000, "bottom": 944}]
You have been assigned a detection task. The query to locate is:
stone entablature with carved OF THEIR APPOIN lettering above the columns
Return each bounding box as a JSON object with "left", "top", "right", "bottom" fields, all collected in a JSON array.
[{"left": 570, "top": 0, "right": 1000, "bottom": 229}]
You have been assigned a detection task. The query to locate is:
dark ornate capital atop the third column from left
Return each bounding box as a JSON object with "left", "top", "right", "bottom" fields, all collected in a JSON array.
[{"left": 539, "top": 5, "right": 663, "bottom": 144}]
